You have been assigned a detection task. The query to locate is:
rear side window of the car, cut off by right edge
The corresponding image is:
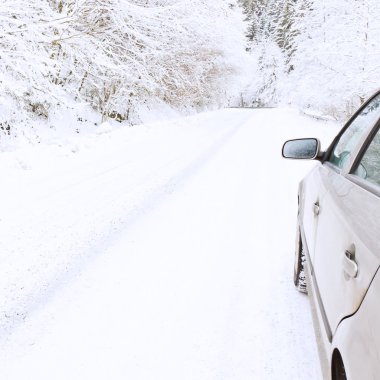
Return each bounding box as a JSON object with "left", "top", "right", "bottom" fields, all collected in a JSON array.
[{"left": 354, "top": 130, "right": 380, "bottom": 186}]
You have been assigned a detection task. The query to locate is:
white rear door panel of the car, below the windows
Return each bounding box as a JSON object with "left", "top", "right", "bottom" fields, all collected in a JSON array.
[{"left": 303, "top": 165, "right": 380, "bottom": 333}]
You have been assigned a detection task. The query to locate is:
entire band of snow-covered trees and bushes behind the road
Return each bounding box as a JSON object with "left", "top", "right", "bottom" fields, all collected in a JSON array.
[{"left": 0, "top": 0, "right": 380, "bottom": 147}]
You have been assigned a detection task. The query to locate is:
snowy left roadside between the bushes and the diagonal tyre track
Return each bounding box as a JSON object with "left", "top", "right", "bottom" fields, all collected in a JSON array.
[{"left": 0, "top": 108, "right": 255, "bottom": 338}]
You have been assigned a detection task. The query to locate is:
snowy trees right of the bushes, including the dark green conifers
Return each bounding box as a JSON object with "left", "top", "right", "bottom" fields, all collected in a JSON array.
[{"left": 240, "top": 0, "right": 380, "bottom": 120}]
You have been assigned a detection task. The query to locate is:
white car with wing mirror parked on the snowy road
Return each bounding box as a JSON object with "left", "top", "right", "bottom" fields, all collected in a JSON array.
[{"left": 282, "top": 91, "right": 380, "bottom": 380}]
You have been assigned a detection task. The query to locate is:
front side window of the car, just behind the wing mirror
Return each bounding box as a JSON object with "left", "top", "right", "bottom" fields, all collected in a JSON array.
[{"left": 328, "top": 94, "right": 380, "bottom": 168}]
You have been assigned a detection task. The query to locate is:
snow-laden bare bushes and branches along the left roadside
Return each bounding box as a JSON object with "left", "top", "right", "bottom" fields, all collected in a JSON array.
[{"left": 0, "top": 0, "right": 248, "bottom": 137}]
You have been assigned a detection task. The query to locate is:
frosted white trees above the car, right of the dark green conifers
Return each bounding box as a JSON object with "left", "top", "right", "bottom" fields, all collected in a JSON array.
[{"left": 284, "top": 0, "right": 380, "bottom": 118}]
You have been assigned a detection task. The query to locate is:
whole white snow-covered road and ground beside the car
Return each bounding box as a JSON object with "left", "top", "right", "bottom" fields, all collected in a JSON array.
[{"left": 0, "top": 109, "right": 336, "bottom": 380}]
